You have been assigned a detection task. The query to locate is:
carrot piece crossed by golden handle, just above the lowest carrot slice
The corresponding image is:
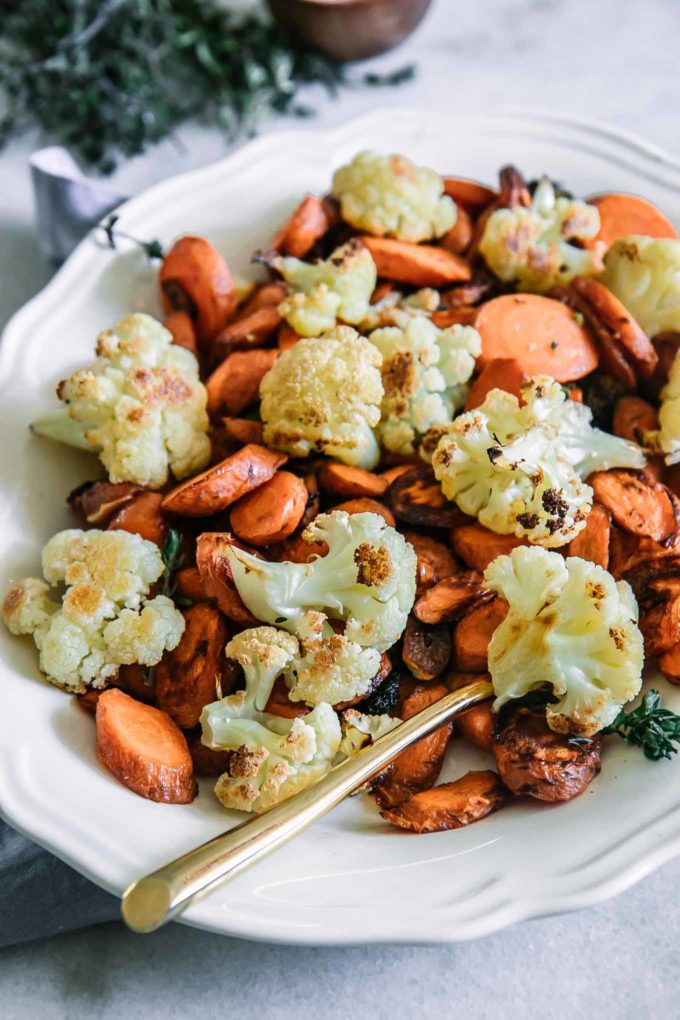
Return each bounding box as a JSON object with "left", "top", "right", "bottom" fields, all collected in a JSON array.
[{"left": 371, "top": 683, "right": 453, "bottom": 808}]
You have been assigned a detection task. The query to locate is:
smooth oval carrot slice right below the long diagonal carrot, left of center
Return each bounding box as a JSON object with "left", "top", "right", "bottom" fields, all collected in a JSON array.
[{"left": 234, "top": 471, "right": 308, "bottom": 546}]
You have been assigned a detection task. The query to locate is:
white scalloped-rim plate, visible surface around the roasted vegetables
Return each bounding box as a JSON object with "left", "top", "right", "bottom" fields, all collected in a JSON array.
[{"left": 0, "top": 109, "right": 680, "bottom": 945}]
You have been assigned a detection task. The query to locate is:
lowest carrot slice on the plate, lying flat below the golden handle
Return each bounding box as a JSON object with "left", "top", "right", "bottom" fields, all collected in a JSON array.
[{"left": 380, "top": 770, "right": 508, "bottom": 832}]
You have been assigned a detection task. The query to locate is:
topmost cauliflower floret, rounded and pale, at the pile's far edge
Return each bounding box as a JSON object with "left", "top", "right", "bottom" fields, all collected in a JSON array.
[{"left": 332, "top": 152, "right": 458, "bottom": 241}]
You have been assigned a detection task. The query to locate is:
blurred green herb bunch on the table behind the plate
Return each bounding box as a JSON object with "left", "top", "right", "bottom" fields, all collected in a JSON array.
[{"left": 0, "top": 0, "right": 413, "bottom": 173}]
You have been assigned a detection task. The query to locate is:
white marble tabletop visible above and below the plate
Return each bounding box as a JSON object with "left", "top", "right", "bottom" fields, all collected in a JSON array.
[{"left": 0, "top": 0, "right": 680, "bottom": 1020}]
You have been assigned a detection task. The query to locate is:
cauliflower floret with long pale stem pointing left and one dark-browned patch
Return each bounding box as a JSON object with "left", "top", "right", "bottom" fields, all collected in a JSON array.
[{"left": 227, "top": 510, "right": 416, "bottom": 652}]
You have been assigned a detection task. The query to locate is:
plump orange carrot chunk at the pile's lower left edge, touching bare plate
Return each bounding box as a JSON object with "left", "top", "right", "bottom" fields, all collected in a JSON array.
[{"left": 96, "top": 687, "right": 197, "bottom": 804}]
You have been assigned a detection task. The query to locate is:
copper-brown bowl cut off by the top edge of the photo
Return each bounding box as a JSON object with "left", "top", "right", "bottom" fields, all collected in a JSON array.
[{"left": 267, "top": 0, "right": 431, "bottom": 60}]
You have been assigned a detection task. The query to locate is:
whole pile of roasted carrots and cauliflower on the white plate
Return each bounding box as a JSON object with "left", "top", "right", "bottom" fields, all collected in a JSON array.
[{"left": 3, "top": 153, "right": 680, "bottom": 832}]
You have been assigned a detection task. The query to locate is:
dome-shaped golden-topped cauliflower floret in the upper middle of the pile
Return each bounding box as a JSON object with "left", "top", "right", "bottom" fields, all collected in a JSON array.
[{"left": 260, "top": 326, "right": 382, "bottom": 468}]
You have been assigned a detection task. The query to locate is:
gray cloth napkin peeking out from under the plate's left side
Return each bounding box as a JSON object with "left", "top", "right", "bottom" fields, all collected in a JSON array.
[{"left": 0, "top": 147, "right": 123, "bottom": 948}]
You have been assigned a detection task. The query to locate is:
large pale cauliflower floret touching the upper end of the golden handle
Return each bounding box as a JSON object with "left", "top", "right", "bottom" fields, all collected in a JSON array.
[{"left": 484, "top": 547, "right": 644, "bottom": 736}]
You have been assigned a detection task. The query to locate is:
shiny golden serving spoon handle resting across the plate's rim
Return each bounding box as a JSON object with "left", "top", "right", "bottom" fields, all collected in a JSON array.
[{"left": 120, "top": 680, "right": 493, "bottom": 932}]
